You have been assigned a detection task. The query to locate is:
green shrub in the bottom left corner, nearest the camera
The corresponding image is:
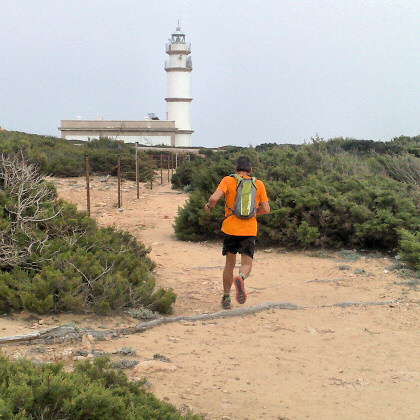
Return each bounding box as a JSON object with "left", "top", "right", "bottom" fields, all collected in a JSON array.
[{"left": 0, "top": 355, "right": 200, "bottom": 420}]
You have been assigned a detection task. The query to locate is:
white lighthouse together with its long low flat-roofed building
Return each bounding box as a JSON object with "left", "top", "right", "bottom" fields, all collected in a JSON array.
[{"left": 58, "top": 26, "right": 193, "bottom": 147}]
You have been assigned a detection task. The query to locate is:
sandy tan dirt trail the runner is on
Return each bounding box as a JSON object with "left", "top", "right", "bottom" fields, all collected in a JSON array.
[{"left": 0, "top": 178, "right": 420, "bottom": 420}]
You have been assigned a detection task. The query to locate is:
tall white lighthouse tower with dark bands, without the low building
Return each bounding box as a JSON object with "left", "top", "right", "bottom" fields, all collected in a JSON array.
[{"left": 165, "top": 22, "right": 193, "bottom": 147}]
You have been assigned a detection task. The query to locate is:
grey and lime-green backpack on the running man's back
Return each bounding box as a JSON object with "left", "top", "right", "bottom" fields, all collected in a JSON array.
[{"left": 226, "top": 174, "right": 257, "bottom": 219}]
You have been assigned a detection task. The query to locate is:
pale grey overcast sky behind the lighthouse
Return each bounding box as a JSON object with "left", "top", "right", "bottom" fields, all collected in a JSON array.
[{"left": 0, "top": 0, "right": 420, "bottom": 147}]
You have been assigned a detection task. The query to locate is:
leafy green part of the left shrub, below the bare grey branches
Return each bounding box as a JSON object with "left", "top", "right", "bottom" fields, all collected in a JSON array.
[{"left": 0, "top": 205, "right": 176, "bottom": 313}]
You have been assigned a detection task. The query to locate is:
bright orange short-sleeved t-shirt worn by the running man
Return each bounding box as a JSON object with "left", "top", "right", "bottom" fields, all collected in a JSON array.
[{"left": 217, "top": 176, "right": 268, "bottom": 236}]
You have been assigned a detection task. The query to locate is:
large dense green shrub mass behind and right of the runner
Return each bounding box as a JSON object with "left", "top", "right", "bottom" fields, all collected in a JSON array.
[{"left": 174, "top": 138, "right": 420, "bottom": 254}]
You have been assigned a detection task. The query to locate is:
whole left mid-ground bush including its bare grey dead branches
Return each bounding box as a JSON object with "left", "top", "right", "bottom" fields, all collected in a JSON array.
[{"left": 0, "top": 156, "right": 176, "bottom": 314}]
